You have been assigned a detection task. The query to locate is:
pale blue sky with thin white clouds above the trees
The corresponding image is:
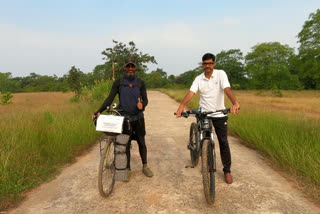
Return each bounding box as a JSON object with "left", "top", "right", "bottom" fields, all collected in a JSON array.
[{"left": 0, "top": 0, "right": 320, "bottom": 77}]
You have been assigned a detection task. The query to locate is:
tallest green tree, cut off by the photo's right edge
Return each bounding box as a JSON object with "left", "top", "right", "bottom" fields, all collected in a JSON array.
[{"left": 296, "top": 9, "right": 320, "bottom": 89}]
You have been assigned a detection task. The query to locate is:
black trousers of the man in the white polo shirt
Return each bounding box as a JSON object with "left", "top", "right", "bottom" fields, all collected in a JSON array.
[{"left": 212, "top": 117, "right": 231, "bottom": 173}]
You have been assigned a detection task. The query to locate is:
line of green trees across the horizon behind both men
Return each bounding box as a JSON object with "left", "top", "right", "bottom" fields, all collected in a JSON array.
[{"left": 0, "top": 9, "right": 320, "bottom": 95}]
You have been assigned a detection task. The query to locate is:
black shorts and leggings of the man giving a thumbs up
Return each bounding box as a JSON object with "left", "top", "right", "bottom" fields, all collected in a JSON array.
[{"left": 126, "top": 118, "right": 147, "bottom": 168}]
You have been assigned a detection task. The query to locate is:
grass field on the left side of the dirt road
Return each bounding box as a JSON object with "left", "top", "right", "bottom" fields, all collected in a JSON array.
[{"left": 0, "top": 92, "right": 98, "bottom": 210}]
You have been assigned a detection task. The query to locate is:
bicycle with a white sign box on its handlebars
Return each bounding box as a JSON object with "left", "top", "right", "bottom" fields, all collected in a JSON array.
[{"left": 92, "top": 104, "right": 131, "bottom": 197}]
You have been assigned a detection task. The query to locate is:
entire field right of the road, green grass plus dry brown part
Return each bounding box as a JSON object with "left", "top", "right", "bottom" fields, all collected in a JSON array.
[{"left": 161, "top": 89, "right": 320, "bottom": 202}]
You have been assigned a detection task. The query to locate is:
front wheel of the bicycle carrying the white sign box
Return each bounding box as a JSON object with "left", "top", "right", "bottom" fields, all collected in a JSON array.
[{"left": 98, "top": 141, "right": 115, "bottom": 197}]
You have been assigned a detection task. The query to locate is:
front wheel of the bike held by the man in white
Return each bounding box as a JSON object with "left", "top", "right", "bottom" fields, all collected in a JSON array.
[{"left": 201, "top": 139, "right": 215, "bottom": 205}]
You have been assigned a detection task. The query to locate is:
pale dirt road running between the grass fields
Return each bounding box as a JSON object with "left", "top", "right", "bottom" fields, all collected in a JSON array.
[{"left": 9, "top": 91, "right": 320, "bottom": 214}]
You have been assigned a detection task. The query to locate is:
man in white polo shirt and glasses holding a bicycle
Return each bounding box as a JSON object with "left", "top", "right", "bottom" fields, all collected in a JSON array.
[{"left": 176, "top": 53, "right": 240, "bottom": 184}]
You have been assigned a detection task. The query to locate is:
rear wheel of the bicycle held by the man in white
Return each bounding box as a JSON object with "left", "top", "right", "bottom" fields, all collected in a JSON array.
[{"left": 188, "top": 123, "right": 200, "bottom": 166}]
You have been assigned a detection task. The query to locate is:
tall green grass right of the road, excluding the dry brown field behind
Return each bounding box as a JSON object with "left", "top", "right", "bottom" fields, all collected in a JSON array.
[{"left": 160, "top": 89, "right": 320, "bottom": 201}]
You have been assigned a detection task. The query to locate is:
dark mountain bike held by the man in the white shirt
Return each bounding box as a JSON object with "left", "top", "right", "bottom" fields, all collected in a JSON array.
[{"left": 175, "top": 108, "right": 230, "bottom": 205}]
